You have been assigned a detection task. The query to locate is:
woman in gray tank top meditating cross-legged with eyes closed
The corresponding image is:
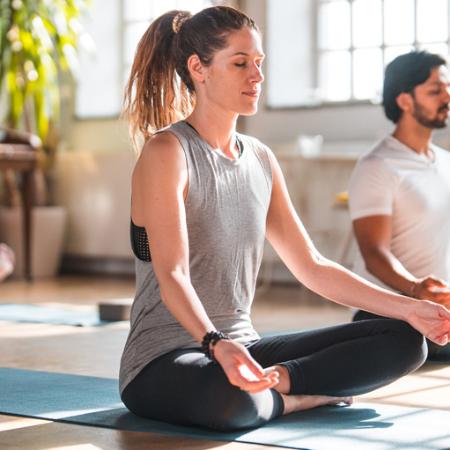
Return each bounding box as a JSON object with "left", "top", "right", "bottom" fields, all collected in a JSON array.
[{"left": 120, "top": 7, "right": 450, "bottom": 430}]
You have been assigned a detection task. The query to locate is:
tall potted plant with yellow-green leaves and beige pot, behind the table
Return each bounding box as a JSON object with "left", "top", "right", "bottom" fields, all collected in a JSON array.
[{"left": 0, "top": 0, "right": 89, "bottom": 277}]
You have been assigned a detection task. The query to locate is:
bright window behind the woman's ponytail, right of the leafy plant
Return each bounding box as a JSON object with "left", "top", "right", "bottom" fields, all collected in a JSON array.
[{"left": 75, "top": 0, "right": 212, "bottom": 118}]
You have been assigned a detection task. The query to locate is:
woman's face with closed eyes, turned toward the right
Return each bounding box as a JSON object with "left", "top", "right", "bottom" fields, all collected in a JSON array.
[{"left": 196, "top": 27, "right": 264, "bottom": 115}]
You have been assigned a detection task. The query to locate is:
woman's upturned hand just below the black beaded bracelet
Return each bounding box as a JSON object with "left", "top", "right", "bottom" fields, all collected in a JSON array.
[{"left": 214, "top": 339, "right": 279, "bottom": 393}]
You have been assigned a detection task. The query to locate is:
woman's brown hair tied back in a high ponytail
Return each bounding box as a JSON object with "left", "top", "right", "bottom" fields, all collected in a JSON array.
[{"left": 124, "top": 6, "right": 258, "bottom": 151}]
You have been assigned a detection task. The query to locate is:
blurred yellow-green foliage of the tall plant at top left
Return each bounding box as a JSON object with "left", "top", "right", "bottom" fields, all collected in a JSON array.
[{"left": 0, "top": 0, "right": 91, "bottom": 150}]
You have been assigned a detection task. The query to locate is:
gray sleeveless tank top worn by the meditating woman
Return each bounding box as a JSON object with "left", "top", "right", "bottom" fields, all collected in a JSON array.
[{"left": 119, "top": 121, "right": 272, "bottom": 392}]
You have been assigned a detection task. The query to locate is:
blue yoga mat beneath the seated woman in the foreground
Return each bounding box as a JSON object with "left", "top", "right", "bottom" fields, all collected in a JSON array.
[{"left": 0, "top": 368, "right": 450, "bottom": 450}]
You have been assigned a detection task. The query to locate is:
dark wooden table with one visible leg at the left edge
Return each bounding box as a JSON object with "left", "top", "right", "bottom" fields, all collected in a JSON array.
[{"left": 0, "top": 144, "right": 38, "bottom": 280}]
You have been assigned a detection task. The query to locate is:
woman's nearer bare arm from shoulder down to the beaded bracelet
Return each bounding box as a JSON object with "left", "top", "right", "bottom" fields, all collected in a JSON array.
[{"left": 132, "top": 133, "right": 215, "bottom": 342}]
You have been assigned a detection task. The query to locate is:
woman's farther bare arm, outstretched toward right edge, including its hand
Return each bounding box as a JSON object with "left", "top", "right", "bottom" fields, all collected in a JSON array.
[{"left": 266, "top": 149, "right": 450, "bottom": 343}]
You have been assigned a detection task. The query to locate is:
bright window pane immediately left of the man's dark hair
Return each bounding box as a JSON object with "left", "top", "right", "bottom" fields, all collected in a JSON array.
[{"left": 353, "top": 49, "right": 383, "bottom": 99}]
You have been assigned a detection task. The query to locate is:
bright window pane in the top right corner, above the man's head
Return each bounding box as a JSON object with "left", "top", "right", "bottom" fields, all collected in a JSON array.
[{"left": 417, "top": 0, "right": 448, "bottom": 42}]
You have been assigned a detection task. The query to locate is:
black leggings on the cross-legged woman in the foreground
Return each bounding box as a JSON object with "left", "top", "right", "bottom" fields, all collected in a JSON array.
[{"left": 122, "top": 319, "right": 426, "bottom": 431}]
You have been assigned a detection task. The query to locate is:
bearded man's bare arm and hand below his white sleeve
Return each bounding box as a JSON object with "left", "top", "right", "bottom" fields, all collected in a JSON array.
[{"left": 353, "top": 215, "right": 450, "bottom": 305}]
